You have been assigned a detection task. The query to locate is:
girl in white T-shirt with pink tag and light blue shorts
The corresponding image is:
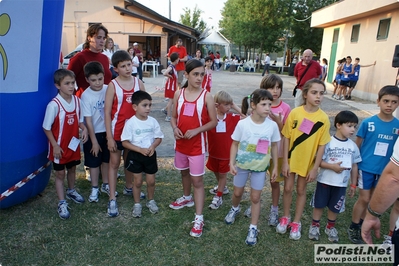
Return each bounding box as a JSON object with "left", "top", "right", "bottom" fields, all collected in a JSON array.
[{"left": 224, "top": 89, "right": 281, "bottom": 246}]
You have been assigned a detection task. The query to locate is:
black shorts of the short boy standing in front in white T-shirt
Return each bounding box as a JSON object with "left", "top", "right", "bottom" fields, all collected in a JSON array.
[{"left": 125, "top": 151, "right": 158, "bottom": 175}]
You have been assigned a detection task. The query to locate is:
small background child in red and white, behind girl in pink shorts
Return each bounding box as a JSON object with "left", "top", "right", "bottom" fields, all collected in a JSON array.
[{"left": 162, "top": 53, "right": 179, "bottom": 122}]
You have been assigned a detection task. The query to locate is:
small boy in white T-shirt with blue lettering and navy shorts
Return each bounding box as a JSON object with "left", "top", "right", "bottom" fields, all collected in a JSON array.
[{"left": 309, "top": 111, "right": 362, "bottom": 243}]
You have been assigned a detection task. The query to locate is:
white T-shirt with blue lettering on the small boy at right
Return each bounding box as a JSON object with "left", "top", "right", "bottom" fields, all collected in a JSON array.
[{"left": 317, "top": 136, "right": 362, "bottom": 187}]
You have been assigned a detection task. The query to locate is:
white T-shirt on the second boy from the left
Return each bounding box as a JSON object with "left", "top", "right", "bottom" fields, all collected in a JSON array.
[{"left": 80, "top": 85, "right": 108, "bottom": 133}]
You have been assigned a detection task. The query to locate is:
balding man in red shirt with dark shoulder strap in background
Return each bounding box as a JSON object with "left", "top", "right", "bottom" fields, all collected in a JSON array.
[{"left": 294, "top": 49, "right": 321, "bottom": 107}]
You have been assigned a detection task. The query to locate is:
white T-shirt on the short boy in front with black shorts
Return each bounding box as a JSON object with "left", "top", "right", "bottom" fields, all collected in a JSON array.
[{"left": 121, "top": 116, "right": 164, "bottom": 148}]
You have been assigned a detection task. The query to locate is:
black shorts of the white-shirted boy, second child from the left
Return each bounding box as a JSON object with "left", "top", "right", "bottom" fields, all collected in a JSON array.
[{"left": 83, "top": 132, "right": 109, "bottom": 168}]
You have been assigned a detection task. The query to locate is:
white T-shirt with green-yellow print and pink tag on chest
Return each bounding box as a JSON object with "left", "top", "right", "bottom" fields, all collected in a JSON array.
[{"left": 231, "top": 116, "right": 281, "bottom": 172}]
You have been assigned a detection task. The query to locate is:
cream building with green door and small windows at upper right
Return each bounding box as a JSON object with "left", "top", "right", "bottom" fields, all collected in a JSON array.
[{"left": 311, "top": 0, "right": 399, "bottom": 101}]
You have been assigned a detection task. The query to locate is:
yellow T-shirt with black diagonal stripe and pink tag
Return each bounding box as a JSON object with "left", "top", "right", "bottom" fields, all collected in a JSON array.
[{"left": 281, "top": 106, "right": 331, "bottom": 177}]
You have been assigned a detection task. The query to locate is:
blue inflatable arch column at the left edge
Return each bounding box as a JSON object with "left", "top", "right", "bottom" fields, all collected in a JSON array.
[{"left": 0, "top": 0, "right": 64, "bottom": 208}]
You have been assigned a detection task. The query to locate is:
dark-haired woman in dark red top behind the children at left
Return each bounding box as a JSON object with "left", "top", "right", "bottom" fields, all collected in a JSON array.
[{"left": 68, "top": 23, "right": 112, "bottom": 97}]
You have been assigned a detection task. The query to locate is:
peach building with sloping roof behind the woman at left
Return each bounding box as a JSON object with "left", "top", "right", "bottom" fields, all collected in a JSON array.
[{"left": 61, "top": 0, "right": 200, "bottom": 66}]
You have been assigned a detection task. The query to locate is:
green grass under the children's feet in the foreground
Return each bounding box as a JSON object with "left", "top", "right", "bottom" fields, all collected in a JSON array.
[{"left": 0, "top": 158, "right": 389, "bottom": 266}]
